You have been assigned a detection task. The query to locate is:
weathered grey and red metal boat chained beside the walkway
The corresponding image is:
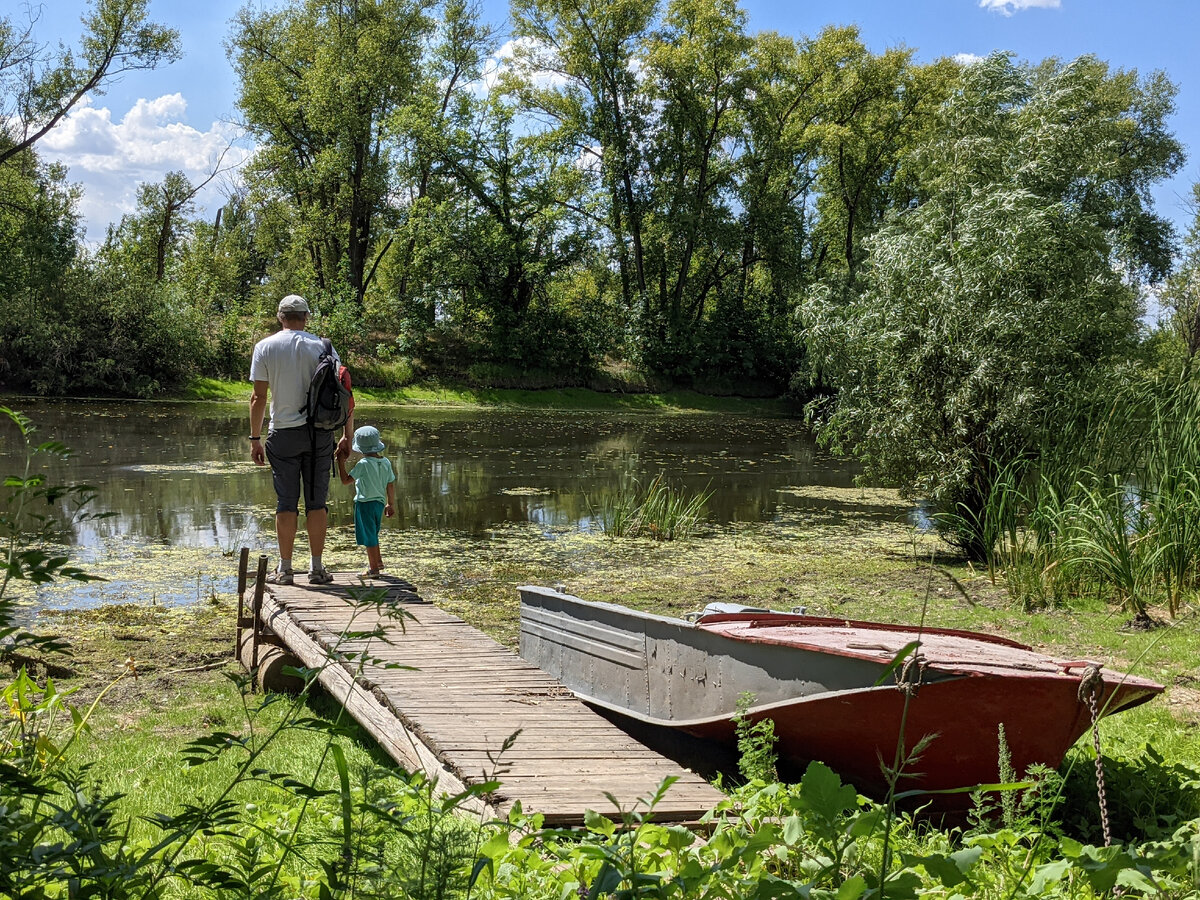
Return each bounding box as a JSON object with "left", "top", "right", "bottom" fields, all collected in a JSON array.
[{"left": 521, "top": 587, "right": 1163, "bottom": 810}]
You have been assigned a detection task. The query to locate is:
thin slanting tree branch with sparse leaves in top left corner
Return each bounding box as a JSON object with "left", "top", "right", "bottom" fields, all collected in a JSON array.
[{"left": 0, "top": 0, "right": 180, "bottom": 164}]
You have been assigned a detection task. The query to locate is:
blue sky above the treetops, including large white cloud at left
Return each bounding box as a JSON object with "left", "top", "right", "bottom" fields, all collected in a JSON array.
[{"left": 25, "top": 0, "right": 1200, "bottom": 241}]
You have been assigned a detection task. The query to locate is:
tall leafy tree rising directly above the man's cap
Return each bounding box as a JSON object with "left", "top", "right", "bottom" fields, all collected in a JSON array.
[{"left": 228, "top": 0, "right": 433, "bottom": 307}]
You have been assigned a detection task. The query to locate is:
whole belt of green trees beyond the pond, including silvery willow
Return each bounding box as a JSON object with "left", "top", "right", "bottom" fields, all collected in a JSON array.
[{"left": 0, "top": 0, "right": 1200, "bottom": 557}]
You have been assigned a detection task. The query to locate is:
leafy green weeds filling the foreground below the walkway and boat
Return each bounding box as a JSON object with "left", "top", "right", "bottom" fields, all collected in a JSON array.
[{"left": 9, "top": 657, "right": 1200, "bottom": 900}]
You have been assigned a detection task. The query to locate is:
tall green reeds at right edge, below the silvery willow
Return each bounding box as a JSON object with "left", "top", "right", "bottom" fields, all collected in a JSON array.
[{"left": 942, "top": 378, "right": 1200, "bottom": 625}]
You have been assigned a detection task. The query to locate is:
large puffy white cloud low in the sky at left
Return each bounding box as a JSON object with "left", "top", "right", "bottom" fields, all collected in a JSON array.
[{"left": 37, "top": 94, "right": 253, "bottom": 241}]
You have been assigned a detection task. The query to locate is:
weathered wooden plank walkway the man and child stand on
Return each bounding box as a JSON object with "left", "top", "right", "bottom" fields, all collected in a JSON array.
[{"left": 239, "top": 561, "right": 722, "bottom": 824}]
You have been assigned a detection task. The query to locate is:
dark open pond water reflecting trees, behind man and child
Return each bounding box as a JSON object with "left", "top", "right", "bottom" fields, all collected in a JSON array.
[{"left": 0, "top": 401, "right": 856, "bottom": 602}]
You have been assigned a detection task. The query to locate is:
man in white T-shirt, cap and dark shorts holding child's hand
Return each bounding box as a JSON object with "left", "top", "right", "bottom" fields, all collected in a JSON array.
[{"left": 250, "top": 294, "right": 354, "bottom": 584}]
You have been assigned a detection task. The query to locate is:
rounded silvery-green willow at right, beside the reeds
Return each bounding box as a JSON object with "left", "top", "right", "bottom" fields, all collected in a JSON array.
[{"left": 815, "top": 54, "right": 1182, "bottom": 554}]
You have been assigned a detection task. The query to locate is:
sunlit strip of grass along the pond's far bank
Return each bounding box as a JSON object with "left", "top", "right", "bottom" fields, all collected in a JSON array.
[{"left": 172, "top": 378, "right": 796, "bottom": 415}]
